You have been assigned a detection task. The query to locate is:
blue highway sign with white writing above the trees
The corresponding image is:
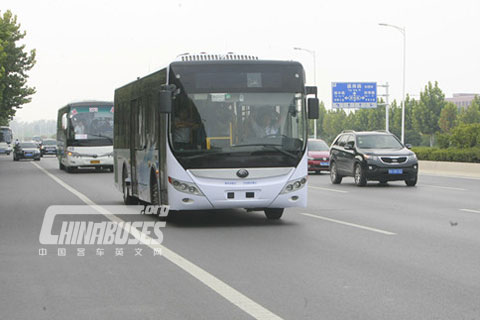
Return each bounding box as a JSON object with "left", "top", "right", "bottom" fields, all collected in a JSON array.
[{"left": 332, "top": 82, "right": 377, "bottom": 109}]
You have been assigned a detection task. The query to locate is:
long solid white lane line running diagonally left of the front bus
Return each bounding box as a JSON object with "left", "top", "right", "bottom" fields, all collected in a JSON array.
[{"left": 32, "top": 162, "right": 282, "bottom": 319}]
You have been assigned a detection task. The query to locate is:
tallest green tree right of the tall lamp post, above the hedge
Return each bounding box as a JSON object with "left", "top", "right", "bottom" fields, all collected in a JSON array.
[{"left": 413, "top": 81, "right": 445, "bottom": 147}]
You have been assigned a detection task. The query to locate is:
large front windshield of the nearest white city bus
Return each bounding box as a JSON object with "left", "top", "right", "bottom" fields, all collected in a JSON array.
[{"left": 170, "top": 61, "right": 306, "bottom": 169}]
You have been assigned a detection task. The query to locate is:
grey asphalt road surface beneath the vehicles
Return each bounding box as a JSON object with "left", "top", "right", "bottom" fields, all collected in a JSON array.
[{"left": 0, "top": 156, "right": 480, "bottom": 319}]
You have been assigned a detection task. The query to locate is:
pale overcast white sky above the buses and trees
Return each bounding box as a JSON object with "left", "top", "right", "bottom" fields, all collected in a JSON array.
[{"left": 0, "top": 0, "right": 480, "bottom": 121}]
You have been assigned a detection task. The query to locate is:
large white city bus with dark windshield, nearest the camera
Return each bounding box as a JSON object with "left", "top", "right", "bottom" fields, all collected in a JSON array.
[{"left": 114, "top": 54, "right": 318, "bottom": 219}]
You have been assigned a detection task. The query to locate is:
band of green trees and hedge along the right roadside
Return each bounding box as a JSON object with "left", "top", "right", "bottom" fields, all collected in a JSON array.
[{"left": 310, "top": 82, "right": 480, "bottom": 162}]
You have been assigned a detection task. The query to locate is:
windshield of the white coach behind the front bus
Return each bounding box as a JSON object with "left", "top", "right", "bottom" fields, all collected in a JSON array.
[{"left": 68, "top": 106, "right": 113, "bottom": 146}]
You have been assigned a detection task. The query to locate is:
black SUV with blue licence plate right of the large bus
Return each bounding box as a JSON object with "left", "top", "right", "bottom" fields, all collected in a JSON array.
[{"left": 330, "top": 131, "right": 418, "bottom": 187}]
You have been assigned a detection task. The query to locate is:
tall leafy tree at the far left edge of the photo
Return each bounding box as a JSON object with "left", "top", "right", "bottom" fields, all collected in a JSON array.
[{"left": 0, "top": 10, "right": 36, "bottom": 121}]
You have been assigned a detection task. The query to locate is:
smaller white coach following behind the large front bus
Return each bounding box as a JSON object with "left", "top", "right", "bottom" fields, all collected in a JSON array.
[{"left": 57, "top": 101, "right": 113, "bottom": 172}]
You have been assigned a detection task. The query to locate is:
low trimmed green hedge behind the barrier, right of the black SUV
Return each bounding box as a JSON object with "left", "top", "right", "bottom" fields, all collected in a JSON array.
[{"left": 412, "top": 147, "right": 480, "bottom": 163}]
